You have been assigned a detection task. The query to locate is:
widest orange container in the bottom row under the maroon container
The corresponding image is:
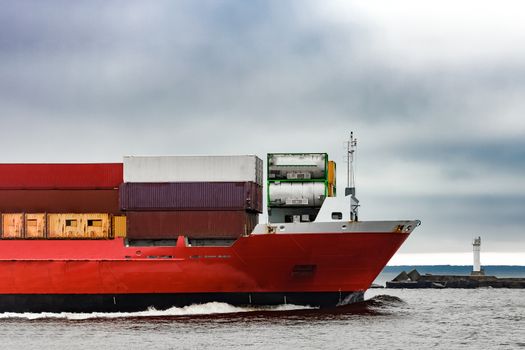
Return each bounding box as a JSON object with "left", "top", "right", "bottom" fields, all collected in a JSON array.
[{"left": 47, "top": 213, "right": 110, "bottom": 239}]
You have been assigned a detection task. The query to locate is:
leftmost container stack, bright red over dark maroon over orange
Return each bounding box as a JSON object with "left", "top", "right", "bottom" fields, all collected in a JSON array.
[{"left": 0, "top": 163, "right": 123, "bottom": 239}]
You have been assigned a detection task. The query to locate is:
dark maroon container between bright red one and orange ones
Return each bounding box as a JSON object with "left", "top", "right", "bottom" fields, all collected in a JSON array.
[{"left": 0, "top": 189, "right": 119, "bottom": 214}]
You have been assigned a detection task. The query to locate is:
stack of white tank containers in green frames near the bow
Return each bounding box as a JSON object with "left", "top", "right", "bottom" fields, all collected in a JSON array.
[{"left": 268, "top": 153, "right": 336, "bottom": 223}]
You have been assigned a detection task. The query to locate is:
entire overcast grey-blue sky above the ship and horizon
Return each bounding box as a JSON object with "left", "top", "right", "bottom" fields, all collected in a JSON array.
[{"left": 0, "top": 0, "right": 525, "bottom": 265}]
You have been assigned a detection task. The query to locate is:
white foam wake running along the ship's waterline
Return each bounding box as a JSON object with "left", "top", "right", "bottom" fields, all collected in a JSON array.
[{"left": 0, "top": 302, "right": 311, "bottom": 320}]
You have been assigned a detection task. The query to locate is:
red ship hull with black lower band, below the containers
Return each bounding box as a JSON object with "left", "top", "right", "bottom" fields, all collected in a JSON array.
[{"left": 0, "top": 232, "right": 409, "bottom": 312}]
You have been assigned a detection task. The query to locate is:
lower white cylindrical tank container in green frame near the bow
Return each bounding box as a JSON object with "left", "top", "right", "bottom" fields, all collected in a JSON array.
[{"left": 268, "top": 182, "right": 328, "bottom": 207}]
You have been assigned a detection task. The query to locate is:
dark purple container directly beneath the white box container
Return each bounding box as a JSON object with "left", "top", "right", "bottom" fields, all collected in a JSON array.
[{"left": 120, "top": 182, "right": 262, "bottom": 213}]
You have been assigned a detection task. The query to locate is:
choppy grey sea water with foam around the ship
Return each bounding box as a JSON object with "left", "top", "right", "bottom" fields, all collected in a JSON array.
[{"left": 0, "top": 267, "right": 525, "bottom": 350}]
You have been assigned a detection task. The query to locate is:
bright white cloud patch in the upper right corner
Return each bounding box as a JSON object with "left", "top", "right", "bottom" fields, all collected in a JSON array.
[{"left": 313, "top": 0, "right": 525, "bottom": 67}]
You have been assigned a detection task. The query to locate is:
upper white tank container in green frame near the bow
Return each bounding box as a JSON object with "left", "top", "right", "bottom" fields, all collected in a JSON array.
[{"left": 268, "top": 153, "right": 328, "bottom": 181}]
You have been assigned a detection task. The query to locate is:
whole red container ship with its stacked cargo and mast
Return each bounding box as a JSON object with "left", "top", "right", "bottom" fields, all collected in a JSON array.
[{"left": 0, "top": 137, "right": 419, "bottom": 312}]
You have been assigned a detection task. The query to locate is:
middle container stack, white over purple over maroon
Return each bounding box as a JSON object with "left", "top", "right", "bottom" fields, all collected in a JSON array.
[{"left": 120, "top": 156, "right": 263, "bottom": 239}]
